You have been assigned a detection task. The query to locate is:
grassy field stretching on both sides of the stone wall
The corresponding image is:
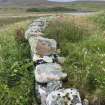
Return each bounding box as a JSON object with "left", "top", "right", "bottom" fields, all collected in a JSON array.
[{"left": 0, "top": 3, "right": 105, "bottom": 105}]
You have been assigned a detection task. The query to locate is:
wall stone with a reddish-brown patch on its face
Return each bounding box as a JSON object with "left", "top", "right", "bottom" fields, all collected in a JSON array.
[{"left": 29, "top": 36, "right": 57, "bottom": 57}]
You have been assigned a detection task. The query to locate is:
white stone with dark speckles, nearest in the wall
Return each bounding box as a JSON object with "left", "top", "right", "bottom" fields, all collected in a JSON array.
[{"left": 46, "top": 89, "right": 82, "bottom": 105}]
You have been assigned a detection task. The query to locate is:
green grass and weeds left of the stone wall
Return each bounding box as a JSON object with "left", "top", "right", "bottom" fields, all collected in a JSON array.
[{"left": 0, "top": 19, "right": 37, "bottom": 105}]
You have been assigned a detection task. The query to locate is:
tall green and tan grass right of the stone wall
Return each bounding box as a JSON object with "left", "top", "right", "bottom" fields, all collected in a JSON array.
[{"left": 45, "top": 14, "right": 105, "bottom": 105}]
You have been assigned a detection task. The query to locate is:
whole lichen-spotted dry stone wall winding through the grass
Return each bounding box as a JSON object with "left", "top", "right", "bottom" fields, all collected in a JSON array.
[{"left": 25, "top": 16, "right": 82, "bottom": 105}]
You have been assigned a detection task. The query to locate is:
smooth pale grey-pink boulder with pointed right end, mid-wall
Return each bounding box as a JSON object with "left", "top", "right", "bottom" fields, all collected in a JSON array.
[{"left": 35, "top": 63, "right": 67, "bottom": 83}]
